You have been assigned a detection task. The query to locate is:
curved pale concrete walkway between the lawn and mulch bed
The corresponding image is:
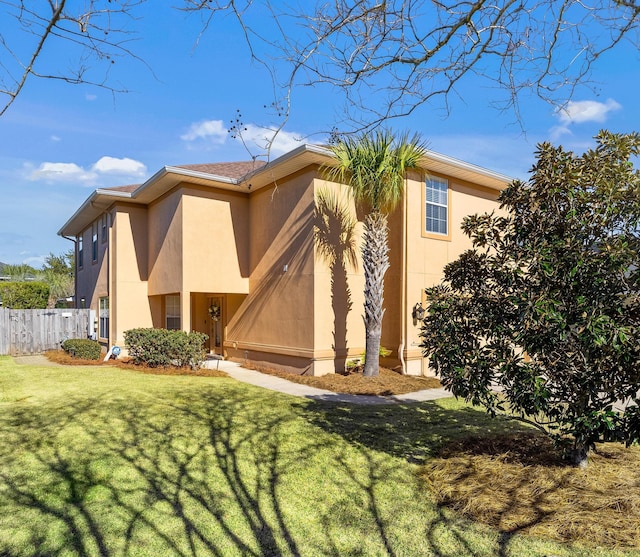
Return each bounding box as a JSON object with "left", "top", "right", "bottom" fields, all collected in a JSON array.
[{"left": 205, "top": 360, "right": 453, "bottom": 404}]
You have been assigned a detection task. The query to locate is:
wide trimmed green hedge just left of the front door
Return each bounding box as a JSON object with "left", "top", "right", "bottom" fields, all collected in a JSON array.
[{"left": 124, "top": 329, "right": 209, "bottom": 369}]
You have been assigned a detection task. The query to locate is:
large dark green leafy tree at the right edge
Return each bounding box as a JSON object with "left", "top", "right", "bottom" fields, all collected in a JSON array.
[{"left": 422, "top": 132, "right": 640, "bottom": 466}]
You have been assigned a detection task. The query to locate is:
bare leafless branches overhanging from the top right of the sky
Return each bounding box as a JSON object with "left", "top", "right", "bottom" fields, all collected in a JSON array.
[{"left": 185, "top": 0, "right": 640, "bottom": 129}]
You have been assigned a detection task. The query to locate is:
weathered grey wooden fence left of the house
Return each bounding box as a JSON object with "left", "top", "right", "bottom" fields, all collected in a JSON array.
[{"left": 0, "top": 308, "right": 90, "bottom": 356}]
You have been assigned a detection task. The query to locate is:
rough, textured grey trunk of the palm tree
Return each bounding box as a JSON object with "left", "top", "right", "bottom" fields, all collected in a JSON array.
[{"left": 362, "top": 212, "right": 389, "bottom": 377}]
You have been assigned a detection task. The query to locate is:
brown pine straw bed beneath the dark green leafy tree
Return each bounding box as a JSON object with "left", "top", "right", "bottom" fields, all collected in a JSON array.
[{"left": 423, "top": 433, "right": 640, "bottom": 548}]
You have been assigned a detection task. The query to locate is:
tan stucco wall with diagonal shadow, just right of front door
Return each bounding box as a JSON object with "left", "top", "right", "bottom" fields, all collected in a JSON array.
[{"left": 227, "top": 169, "right": 314, "bottom": 359}]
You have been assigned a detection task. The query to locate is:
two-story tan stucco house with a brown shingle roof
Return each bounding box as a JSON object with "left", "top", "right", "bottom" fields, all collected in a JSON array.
[{"left": 59, "top": 145, "right": 510, "bottom": 375}]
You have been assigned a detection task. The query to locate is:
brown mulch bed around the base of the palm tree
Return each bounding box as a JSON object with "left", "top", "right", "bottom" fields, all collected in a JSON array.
[{"left": 244, "top": 366, "right": 442, "bottom": 396}]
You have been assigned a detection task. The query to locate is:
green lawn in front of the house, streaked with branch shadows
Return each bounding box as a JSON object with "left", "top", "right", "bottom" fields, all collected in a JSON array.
[{"left": 0, "top": 357, "right": 630, "bottom": 557}]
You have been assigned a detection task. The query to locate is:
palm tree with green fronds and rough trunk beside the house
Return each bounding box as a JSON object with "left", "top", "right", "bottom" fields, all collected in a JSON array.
[{"left": 324, "top": 130, "right": 427, "bottom": 377}]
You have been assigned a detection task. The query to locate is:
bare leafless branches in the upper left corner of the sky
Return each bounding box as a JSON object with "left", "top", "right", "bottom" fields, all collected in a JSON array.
[{"left": 0, "top": 0, "right": 145, "bottom": 116}]
